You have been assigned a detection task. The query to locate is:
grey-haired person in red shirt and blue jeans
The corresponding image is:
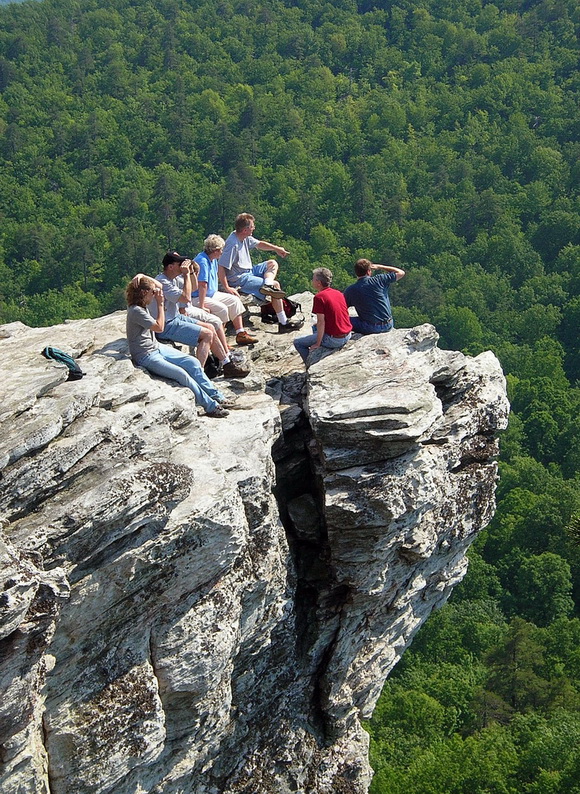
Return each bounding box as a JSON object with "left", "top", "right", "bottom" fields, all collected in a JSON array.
[{"left": 294, "top": 267, "right": 352, "bottom": 363}]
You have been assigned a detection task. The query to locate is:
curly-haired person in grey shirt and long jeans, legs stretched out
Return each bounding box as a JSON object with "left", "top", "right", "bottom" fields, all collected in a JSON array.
[{"left": 126, "top": 273, "right": 229, "bottom": 419}]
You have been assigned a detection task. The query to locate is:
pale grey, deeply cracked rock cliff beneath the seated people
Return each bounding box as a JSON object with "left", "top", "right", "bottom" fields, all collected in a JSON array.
[{"left": 0, "top": 308, "right": 508, "bottom": 794}]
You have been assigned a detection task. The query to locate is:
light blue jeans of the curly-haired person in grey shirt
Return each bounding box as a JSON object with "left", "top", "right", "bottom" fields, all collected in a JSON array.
[{"left": 138, "top": 345, "right": 224, "bottom": 412}]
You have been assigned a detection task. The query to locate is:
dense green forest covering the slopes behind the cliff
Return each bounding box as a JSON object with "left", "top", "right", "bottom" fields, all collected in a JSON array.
[{"left": 0, "top": 0, "right": 580, "bottom": 794}]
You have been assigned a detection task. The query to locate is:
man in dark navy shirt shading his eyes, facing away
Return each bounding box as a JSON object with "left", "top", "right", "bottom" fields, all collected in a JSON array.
[{"left": 344, "top": 259, "right": 405, "bottom": 334}]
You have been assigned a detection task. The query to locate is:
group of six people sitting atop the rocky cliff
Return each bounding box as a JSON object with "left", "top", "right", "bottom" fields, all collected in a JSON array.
[{"left": 126, "top": 213, "right": 405, "bottom": 418}]
